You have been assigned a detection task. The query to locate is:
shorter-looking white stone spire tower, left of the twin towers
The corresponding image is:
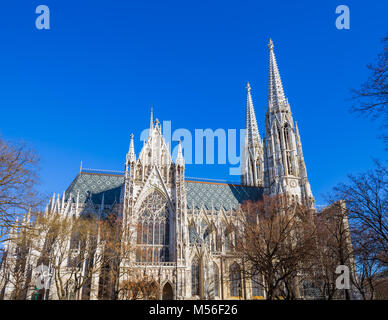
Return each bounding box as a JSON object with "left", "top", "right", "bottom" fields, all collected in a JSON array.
[{"left": 241, "top": 82, "right": 264, "bottom": 187}]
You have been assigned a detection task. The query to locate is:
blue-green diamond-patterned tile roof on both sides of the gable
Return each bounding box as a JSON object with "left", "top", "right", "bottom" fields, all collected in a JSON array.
[{"left": 65, "top": 172, "right": 263, "bottom": 210}]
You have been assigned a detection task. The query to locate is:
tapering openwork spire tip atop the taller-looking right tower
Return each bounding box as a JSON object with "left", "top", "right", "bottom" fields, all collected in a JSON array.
[{"left": 268, "top": 39, "right": 286, "bottom": 111}]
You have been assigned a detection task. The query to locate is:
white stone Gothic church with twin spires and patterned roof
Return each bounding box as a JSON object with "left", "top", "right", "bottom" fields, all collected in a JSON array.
[{"left": 0, "top": 40, "right": 314, "bottom": 299}]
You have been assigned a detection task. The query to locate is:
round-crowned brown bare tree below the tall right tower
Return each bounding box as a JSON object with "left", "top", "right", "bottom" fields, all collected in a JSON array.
[{"left": 236, "top": 196, "right": 314, "bottom": 299}]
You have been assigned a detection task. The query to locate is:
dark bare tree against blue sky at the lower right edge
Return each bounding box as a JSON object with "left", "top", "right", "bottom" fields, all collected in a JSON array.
[{"left": 332, "top": 161, "right": 388, "bottom": 299}]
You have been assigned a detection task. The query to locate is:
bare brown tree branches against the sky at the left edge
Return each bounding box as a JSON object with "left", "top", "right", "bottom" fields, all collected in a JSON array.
[{"left": 0, "top": 137, "right": 38, "bottom": 242}]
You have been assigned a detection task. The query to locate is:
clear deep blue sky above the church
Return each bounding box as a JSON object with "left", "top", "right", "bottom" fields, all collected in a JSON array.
[{"left": 0, "top": 0, "right": 388, "bottom": 204}]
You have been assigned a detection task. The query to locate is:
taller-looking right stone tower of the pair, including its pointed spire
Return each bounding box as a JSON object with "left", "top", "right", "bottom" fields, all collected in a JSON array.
[{"left": 264, "top": 39, "right": 314, "bottom": 207}]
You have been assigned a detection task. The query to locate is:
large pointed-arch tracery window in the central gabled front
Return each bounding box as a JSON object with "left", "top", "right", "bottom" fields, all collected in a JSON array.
[{"left": 136, "top": 190, "right": 170, "bottom": 263}]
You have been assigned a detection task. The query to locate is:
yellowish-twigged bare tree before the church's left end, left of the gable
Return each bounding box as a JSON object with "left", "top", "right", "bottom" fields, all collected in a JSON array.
[{"left": 23, "top": 213, "right": 103, "bottom": 300}]
